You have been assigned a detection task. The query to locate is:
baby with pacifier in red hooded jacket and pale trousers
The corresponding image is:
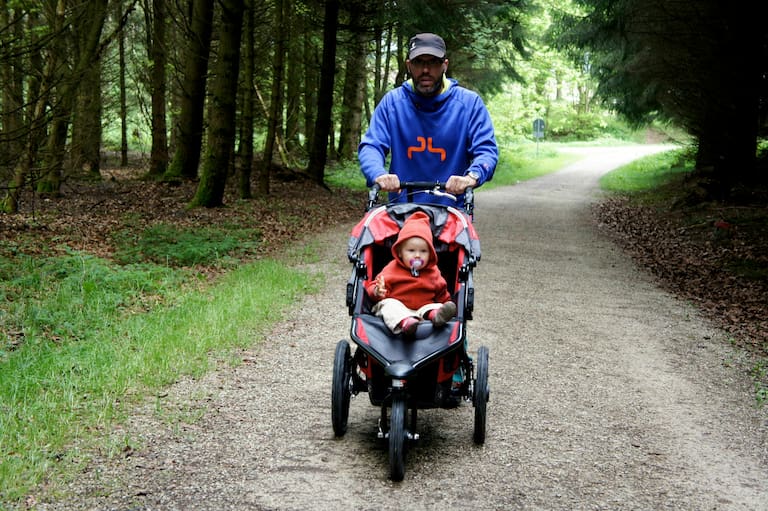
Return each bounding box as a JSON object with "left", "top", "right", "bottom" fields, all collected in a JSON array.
[{"left": 366, "top": 211, "right": 456, "bottom": 337}]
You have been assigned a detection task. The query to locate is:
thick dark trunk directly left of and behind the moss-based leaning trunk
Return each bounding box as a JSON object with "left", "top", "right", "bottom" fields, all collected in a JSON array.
[{"left": 164, "top": 0, "right": 214, "bottom": 180}]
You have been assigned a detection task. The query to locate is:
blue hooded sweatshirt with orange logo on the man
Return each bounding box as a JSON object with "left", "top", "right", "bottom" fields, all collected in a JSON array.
[{"left": 358, "top": 77, "right": 499, "bottom": 207}]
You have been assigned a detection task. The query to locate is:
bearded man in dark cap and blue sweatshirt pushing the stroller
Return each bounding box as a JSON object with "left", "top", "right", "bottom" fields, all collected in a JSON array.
[{"left": 358, "top": 33, "right": 498, "bottom": 206}]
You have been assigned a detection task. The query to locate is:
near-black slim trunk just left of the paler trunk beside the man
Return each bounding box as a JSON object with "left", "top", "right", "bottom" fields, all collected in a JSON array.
[{"left": 307, "top": 0, "right": 339, "bottom": 186}]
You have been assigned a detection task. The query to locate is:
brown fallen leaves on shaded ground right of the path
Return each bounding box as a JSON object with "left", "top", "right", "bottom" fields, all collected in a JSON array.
[{"left": 594, "top": 197, "right": 768, "bottom": 356}]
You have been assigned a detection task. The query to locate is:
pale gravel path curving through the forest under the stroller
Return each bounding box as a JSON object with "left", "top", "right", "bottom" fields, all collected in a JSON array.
[{"left": 38, "top": 147, "right": 768, "bottom": 511}]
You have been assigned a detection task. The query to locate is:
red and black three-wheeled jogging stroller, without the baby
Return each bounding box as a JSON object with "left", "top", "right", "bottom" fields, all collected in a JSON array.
[{"left": 331, "top": 182, "right": 489, "bottom": 481}]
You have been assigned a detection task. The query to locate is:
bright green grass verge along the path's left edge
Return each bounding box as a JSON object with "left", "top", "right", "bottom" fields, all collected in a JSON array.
[{"left": 0, "top": 251, "right": 321, "bottom": 508}]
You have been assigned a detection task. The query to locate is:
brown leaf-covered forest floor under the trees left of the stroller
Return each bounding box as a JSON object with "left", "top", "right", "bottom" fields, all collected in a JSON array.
[{"left": 0, "top": 169, "right": 365, "bottom": 264}]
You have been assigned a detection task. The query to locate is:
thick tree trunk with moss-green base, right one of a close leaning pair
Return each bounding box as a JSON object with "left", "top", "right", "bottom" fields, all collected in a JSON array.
[{"left": 191, "top": 0, "right": 244, "bottom": 208}]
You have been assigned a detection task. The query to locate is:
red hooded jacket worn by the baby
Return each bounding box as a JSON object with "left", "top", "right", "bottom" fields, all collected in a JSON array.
[{"left": 365, "top": 211, "right": 451, "bottom": 310}]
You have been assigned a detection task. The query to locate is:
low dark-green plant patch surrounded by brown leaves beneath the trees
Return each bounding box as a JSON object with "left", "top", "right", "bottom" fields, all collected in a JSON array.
[{"left": 115, "top": 224, "right": 260, "bottom": 266}]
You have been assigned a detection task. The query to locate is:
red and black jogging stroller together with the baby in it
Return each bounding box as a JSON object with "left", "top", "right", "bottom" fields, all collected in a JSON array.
[{"left": 331, "top": 182, "right": 490, "bottom": 481}]
